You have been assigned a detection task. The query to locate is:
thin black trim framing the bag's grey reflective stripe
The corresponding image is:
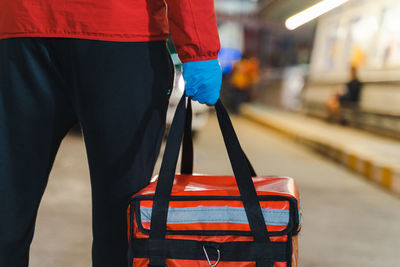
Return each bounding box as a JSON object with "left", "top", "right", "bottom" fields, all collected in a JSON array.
[{"left": 131, "top": 195, "right": 299, "bottom": 236}]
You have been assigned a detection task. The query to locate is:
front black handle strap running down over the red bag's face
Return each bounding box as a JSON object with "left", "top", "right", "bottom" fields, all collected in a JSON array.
[{"left": 149, "top": 96, "right": 270, "bottom": 266}]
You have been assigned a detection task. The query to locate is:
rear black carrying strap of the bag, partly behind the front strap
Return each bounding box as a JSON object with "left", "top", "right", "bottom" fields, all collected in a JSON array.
[{"left": 181, "top": 98, "right": 257, "bottom": 177}]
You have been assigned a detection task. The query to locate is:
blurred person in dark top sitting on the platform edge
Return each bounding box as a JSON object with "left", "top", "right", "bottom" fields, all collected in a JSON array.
[{"left": 327, "top": 65, "right": 362, "bottom": 123}]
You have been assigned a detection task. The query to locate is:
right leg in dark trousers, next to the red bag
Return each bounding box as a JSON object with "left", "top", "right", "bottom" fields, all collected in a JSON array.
[{"left": 66, "top": 40, "right": 173, "bottom": 267}]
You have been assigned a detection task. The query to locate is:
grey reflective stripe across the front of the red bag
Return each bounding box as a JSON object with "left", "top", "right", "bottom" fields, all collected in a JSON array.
[{"left": 140, "top": 207, "right": 289, "bottom": 226}]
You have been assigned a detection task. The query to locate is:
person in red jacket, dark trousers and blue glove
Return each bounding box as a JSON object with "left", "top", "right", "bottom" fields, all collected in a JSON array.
[{"left": 0, "top": 0, "right": 221, "bottom": 267}]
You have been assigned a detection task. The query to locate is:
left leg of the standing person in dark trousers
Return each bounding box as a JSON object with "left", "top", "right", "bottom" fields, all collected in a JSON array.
[{"left": 0, "top": 38, "right": 75, "bottom": 267}]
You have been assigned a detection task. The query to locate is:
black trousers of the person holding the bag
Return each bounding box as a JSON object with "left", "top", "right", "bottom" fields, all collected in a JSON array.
[{"left": 0, "top": 38, "right": 173, "bottom": 267}]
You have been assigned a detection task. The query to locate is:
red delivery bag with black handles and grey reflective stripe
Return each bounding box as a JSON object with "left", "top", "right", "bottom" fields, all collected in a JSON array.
[{"left": 128, "top": 97, "right": 300, "bottom": 267}]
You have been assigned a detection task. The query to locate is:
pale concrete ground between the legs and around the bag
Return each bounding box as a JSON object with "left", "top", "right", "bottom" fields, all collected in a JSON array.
[{"left": 30, "top": 117, "right": 400, "bottom": 267}]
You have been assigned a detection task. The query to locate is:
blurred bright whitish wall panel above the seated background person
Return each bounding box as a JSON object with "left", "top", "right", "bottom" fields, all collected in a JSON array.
[{"left": 311, "top": 0, "right": 400, "bottom": 82}]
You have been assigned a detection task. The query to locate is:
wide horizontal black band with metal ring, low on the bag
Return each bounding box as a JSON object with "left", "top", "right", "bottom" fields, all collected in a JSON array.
[{"left": 133, "top": 239, "right": 291, "bottom": 262}]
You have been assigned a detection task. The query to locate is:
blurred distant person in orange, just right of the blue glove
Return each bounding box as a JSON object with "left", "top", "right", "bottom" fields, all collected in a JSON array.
[{"left": 230, "top": 54, "right": 259, "bottom": 113}]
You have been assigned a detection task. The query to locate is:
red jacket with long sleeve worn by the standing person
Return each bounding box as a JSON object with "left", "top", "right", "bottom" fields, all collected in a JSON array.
[{"left": 0, "top": 0, "right": 220, "bottom": 62}]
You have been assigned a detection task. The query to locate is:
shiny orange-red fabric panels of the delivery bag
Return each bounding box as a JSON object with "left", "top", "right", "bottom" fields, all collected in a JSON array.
[{"left": 128, "top": 174, "right": 300, "bottom": 267}]
